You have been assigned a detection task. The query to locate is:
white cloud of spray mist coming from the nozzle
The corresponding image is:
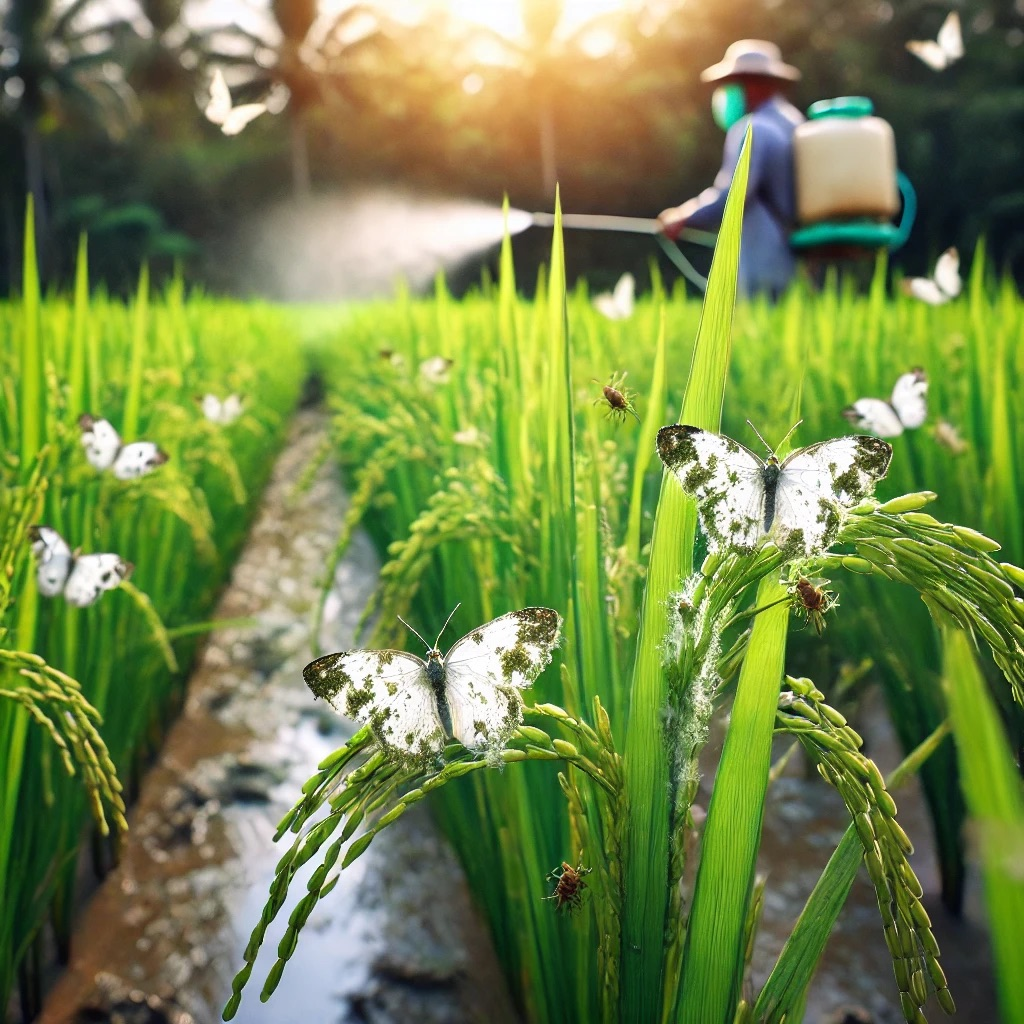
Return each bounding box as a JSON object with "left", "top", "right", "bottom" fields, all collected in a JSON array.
[{"left": 221, "top": 188, "right": 534, "bottom": 302}]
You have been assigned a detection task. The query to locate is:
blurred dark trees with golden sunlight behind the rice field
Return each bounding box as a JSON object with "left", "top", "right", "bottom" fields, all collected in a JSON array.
[{"left": 0, "top": 0, "right": 1024, "bottom": 292}]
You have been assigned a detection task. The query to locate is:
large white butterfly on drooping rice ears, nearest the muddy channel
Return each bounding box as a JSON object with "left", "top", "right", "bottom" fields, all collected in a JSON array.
[{"left": 302, "top": 606, "right": 562, "bottom": 760}]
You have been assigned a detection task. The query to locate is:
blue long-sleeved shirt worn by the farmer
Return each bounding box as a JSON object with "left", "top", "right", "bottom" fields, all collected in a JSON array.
[{"left": 684, "top": 96, "right": 804, "bottom": 295}]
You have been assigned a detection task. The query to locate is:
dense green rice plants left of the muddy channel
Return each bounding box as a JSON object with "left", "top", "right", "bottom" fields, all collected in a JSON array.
[{"left": 0, "top": 206, "right": 303, "bottom": 1019}]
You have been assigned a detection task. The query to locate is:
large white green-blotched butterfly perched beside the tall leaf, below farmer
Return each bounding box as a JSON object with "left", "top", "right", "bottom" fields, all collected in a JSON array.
[{"left": 657, "top": 424, "right": 893, "bottom": 557}]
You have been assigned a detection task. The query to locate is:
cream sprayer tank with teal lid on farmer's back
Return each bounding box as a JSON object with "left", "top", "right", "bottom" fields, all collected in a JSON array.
[{"left": 793, "top": 96, "right": 900, "bottom": 224}]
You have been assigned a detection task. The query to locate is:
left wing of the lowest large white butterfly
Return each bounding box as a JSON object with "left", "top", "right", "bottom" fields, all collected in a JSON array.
[{"left": 302, "top": 650, "right": 445, "bottom": 758}]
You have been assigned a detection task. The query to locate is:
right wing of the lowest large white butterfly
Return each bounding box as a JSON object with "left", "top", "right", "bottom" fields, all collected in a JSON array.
[{"left": 444, "top": 608, "right": 562, "bottom": 749}]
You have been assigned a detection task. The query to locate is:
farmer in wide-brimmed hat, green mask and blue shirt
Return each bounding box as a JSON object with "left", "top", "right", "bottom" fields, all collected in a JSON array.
[{"left": 658, "top": 39, "right": 804, "bottom": 298}]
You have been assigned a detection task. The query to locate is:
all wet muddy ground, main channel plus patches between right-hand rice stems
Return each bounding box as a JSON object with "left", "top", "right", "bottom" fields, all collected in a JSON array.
[{"left": 39, "top": 410, "right": 997, "bottom": 1024}]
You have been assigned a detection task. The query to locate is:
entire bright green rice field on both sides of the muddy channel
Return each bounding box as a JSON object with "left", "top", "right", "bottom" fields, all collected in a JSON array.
[{"left": 6, "top": 171, "right": 1024, "bottom": 1024}]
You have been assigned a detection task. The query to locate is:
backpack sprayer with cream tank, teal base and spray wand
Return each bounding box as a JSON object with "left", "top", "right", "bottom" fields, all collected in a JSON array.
[{"left": 530, "top": 96, "right": 918, "bottom": 291}]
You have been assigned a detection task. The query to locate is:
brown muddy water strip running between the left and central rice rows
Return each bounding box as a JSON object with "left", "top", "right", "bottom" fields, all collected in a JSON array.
[{"left": 40, "top": 412, "right": 514, "bottom": 1024}]
